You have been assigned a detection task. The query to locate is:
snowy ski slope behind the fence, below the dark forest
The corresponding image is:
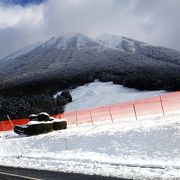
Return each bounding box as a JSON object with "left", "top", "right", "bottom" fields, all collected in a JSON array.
[{"left": 54, "top": 81, "right": 165, "bottom": 111}]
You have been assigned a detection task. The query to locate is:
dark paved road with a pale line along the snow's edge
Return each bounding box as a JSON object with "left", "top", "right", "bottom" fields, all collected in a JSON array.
[{"left": 0, "top": 166, "right": 131, "bottom": 180}]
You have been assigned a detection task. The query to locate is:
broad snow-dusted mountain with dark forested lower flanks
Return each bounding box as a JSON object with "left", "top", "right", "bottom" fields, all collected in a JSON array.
[{"left": 0, "top": 33, "right": 180, "bottom": 94}]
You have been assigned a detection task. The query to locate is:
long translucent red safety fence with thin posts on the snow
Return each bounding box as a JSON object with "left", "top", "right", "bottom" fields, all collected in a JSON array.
[{"left": 0, "top": 91, "right": 180, "bottom": 131}]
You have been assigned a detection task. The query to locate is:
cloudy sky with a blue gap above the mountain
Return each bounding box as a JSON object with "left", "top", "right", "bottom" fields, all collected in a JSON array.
[{"left": 0, "top": 0, "right": 180, "bottom": 58}]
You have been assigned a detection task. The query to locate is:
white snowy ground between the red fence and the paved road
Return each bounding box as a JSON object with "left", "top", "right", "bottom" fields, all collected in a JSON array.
[{"left": 0, "top": 114, "right": 180, "bottom": 179}]
